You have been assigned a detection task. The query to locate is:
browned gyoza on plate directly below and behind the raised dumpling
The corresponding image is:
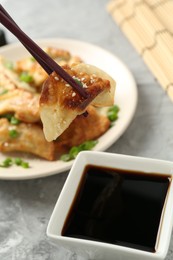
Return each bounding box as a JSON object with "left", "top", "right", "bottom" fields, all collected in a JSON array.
[{"left": 55, "top": 106, "right": 110, "bottom": 154}]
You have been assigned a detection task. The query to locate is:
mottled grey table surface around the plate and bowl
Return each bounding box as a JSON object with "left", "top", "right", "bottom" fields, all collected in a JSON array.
[{"left": 0, "top": 0, "right": 173, "bottom": 260}]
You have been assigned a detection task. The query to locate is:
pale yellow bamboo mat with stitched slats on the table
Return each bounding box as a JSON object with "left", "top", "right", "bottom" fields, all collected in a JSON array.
[{"left": 107, "top": 0, "right": 173, "bottom": 101}]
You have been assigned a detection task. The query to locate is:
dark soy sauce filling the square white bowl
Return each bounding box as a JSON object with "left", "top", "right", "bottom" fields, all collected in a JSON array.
[{"left": 62, "top": 165, "right": 170, "bottom": 252}]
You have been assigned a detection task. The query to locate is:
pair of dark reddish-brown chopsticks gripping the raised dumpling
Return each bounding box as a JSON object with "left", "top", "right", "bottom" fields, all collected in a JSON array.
[{"left": 0, "top": 5, "right": 88, "bottom": 98}]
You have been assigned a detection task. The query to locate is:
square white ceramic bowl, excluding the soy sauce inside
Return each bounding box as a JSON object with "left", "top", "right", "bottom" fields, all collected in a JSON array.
[{"left": 47, "top": 151, "right": 173, "bottom": 260}]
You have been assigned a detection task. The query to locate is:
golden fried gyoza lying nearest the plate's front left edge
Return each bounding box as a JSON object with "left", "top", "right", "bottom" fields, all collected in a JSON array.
[{"left": 0, "top": 118, "right": 55, "bottom": 160}]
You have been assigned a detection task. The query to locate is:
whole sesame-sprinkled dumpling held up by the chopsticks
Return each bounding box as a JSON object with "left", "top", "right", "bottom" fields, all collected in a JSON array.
[{"left": 40, "top": 63, "right": 116, "bottom": 141}]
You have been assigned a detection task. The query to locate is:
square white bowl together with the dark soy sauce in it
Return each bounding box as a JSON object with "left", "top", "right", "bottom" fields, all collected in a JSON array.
[{"left": 47, "top": 151, "right": 173, "bottom": 260}]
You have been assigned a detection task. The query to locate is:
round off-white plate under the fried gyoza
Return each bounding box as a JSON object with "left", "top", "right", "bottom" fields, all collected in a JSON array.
[{"left": 0, "top": 39, "right": 138, "bottom": 180}]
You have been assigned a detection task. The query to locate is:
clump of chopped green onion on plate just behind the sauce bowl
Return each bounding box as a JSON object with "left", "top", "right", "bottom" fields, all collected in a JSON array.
[{"left": 60, "top": 140, "right": 98, "bottom": 162}]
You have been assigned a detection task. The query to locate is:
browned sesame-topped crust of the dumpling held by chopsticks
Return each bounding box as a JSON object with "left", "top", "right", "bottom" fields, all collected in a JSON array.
[{"left": 40, "top": 65, "right": 110, "bottom": 109}]
